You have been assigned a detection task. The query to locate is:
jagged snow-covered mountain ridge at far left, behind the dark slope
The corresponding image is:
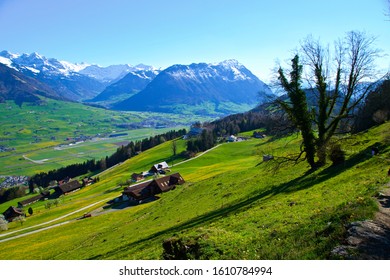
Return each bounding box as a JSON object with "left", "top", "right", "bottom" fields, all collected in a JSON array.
[{"left": 0, "top": 51, "right": 154, "bottom": 102}]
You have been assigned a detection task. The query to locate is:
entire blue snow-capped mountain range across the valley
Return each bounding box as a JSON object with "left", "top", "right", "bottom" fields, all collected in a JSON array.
[{"left": 0, "top": 51, "right": 272, "bottom": 114}]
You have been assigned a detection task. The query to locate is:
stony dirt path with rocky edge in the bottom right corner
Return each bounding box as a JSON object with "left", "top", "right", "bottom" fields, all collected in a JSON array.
[{"left": 333, "top": 183, "right": 390, "bottom": 260}]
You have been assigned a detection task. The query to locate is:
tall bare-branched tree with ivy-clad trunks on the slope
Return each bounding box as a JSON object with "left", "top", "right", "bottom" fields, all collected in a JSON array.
[{"left": 279, "top": 31, "right": 380, "bottom": 167}]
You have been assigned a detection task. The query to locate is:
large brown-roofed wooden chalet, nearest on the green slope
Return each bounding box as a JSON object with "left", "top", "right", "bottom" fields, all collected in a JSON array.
[{"left": 122, "top": 173, "right": 185, "bottom": 201}]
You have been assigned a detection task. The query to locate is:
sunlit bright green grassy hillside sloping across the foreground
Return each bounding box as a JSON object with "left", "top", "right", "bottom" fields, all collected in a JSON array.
[{"left": 0, "top": 123, "right": 390, "bottom": 259}]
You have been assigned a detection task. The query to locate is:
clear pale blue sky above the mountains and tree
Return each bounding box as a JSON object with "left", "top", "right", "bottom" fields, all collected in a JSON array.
[{"left": 0, "top": 0, "right": 390, "bottom": 81}]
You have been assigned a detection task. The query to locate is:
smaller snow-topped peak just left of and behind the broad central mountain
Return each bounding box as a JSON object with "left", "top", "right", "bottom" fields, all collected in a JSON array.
[{"left": 89, "top": 68, "right": 160, "bottom": 106}]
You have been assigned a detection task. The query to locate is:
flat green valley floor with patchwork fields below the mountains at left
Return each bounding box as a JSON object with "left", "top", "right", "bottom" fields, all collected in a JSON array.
[{"left": 0, "top": 99, "right": 210, "bottom": 175}]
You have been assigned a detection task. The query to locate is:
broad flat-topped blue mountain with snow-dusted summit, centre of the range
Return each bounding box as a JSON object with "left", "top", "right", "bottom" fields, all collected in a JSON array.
[{"left": 114, "top": 60, "right": 272, "bottom": 113}]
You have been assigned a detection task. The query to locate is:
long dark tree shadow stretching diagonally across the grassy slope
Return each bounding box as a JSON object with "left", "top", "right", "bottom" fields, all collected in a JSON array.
[{"left": 87, "top": 144, "right": 378, "bottom": 259}]
